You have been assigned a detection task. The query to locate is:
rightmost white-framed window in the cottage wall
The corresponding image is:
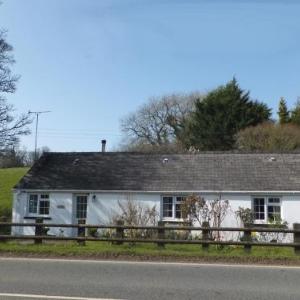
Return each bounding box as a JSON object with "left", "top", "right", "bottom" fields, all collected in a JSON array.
[{"left": 253, "top": 197, "right": 281, "bottom": 222}]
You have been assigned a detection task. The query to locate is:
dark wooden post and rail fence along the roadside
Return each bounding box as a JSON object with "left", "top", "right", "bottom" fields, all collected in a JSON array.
[{"left": 0, "top": 219, "right": 300, "bottom": 255}]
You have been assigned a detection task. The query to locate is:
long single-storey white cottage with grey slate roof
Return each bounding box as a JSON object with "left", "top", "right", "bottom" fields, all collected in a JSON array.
[{"left": 12, "top": 152, "right": 300, "bottom": 236}]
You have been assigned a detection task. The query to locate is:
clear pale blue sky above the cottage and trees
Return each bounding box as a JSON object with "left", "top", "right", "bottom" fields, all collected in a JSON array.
[{"left": 0, "top": 0, "right": 300, "bottom": 151}]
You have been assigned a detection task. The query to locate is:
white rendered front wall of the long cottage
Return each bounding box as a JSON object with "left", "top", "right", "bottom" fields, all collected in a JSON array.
[{"left": 12, "top": 191, "right": 300, "bottom": 236}]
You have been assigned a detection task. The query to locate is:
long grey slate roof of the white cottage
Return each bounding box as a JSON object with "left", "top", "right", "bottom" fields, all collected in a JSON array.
[{"left": 15, "top": 152, "right": 300, "bottom": 191}]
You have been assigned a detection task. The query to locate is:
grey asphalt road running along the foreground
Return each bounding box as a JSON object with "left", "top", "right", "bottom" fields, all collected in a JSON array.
[{"left": 0, "top": 258, "right": 300, "bottom": 300}]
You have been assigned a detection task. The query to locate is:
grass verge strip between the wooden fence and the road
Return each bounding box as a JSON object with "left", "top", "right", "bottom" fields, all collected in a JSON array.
[{"left": 0, "top": 242, "right": 300, "bottom": 265}]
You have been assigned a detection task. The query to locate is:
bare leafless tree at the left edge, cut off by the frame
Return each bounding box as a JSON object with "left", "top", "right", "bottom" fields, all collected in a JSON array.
[{"left": 0, "top": 31, "right": 31, "bottom": 150}]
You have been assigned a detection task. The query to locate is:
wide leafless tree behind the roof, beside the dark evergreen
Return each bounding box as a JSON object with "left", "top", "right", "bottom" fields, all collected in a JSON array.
[{"left": 121, "top": 93, "right": 201, "bottom": 148}]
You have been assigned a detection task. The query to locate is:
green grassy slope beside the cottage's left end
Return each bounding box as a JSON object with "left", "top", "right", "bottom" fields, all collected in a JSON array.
[{"left": 0, "top": 168, "right": 28, "bottom": 216}]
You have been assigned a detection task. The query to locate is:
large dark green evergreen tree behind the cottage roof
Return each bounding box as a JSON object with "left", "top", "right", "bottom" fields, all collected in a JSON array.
[{"left": 186, "top": 78, "right": 271, "bottom": 150}]
